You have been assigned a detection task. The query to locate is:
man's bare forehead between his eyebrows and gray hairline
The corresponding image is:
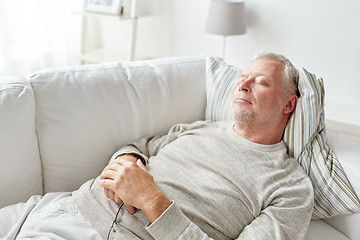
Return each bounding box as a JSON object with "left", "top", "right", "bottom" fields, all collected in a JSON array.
[{"left": 242, "top": 58, "right": 284, "bottom": 80}]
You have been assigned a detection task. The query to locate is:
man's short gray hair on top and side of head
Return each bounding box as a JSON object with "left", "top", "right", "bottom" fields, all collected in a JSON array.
[{"left": 252, "top": 52, "right": 299, "bottom": 96}]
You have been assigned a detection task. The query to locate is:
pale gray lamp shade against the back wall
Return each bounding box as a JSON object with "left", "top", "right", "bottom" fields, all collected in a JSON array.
[{"left": 205, "top": 0, "right": 246, "bottom": 36}]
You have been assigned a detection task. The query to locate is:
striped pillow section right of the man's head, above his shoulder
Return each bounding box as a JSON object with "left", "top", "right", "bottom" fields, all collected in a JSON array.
[{"left": 283, "top": 68, "right": 360, "bottom": 219}]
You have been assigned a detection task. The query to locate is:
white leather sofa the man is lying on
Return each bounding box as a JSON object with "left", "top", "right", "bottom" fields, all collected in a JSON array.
[{"left": 0, "top": 56, "right": 360, "bottom": 240}]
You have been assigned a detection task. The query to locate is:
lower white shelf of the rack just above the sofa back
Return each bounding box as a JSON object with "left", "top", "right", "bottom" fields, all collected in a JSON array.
[{"left": 78, "top": 49, "right": 150, "bottom": 63}]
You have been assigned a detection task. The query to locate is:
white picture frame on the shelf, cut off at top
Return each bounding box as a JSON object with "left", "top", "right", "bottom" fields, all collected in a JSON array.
[{"left": 84, "top": 0, "right": 124, "bottom": 16}]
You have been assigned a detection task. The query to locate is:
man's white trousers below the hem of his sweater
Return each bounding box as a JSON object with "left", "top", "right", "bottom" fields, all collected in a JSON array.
[{"left": 0, "top": 192, "right": 102, "bottom": 240}]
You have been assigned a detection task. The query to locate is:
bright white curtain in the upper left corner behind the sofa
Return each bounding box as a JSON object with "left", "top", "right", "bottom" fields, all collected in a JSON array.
[{"left": 0, "top": 0, "right": 82, "bottom": 76}]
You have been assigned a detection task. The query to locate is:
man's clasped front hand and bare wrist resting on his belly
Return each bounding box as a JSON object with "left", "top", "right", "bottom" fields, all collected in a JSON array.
[{"left": 100, "top": 158, "right": 171, "bottom": 222}]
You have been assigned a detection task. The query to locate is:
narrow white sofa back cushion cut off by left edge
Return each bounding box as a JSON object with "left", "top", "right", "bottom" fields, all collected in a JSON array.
[{"left": 0, "top": 77, "right": 43, "bottom": 208}]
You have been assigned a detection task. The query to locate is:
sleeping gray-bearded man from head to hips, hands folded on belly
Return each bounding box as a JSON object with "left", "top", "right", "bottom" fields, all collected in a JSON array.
[{"left": 1, "top": 53, "right": 313, "bottom": 240}]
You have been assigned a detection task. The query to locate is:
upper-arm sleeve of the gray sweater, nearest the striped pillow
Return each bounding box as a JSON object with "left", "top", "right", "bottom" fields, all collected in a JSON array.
[{"left": 237, "top": 176, "right": 314, "bottom": 240}]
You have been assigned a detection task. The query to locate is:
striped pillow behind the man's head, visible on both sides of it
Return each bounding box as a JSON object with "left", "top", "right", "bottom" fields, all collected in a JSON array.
[{"left": 205, "top": 57, "right": 360, "bottom": 219}]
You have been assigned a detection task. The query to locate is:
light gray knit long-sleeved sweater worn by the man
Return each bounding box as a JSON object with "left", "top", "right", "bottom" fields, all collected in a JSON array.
[{"left": 73, "top": 121, "right": 313, "bottom": 240}]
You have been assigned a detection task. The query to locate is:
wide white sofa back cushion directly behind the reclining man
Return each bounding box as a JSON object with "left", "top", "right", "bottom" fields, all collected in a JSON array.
[{"left": 30, "top": 56, "right": 206, "bottom": 192}]
